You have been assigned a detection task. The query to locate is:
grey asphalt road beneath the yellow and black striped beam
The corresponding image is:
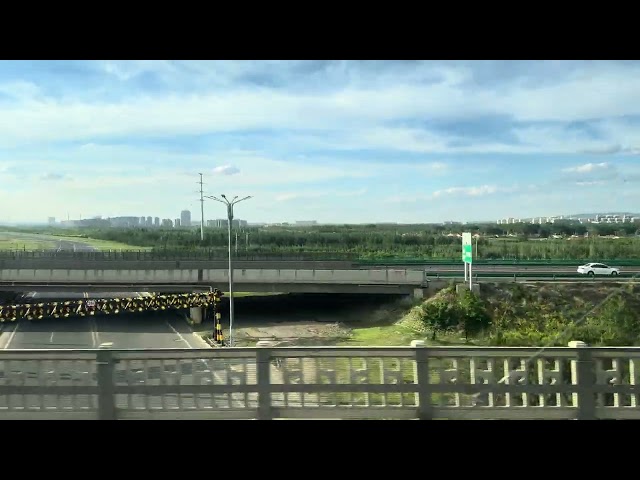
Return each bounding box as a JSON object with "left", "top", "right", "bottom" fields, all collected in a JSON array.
[{"left": 0, "top": 312, "right": 209, "bottom": 350}]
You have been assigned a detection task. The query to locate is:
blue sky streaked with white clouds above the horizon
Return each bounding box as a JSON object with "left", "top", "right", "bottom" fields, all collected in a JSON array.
[{"left": 0, "top": 60, "right": 640, "bottom": 223}]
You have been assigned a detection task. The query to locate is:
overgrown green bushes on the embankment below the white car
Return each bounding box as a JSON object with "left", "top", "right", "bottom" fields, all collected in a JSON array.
[{"left": 400, "top": 284, "right": 640, "bottom": 346}]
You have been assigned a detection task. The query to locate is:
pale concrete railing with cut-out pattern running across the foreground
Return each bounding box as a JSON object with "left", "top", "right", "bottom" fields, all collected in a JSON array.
[{"left": 0, "top": 342, "right": 640, "bottom": 419}]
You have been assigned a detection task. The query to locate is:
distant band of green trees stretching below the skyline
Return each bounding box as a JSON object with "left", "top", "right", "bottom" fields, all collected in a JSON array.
[{"left": 7, "top": 222, "right": 640, "bottom": 261}]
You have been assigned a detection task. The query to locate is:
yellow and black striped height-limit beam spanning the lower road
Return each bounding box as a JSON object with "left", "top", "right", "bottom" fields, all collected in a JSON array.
[{"left": 0, "top": 292, "right": 219, "bottom": 328}]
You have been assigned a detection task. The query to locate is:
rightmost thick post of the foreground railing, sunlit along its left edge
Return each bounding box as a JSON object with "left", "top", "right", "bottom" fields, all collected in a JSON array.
[{"left": 569, "top": 341, "right": 597, "bottom": 420}]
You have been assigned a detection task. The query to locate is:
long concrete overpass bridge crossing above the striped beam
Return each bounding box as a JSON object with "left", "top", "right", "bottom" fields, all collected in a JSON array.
[{"left": 0, "top": 267, "right": 428, "bottom": 298}]
